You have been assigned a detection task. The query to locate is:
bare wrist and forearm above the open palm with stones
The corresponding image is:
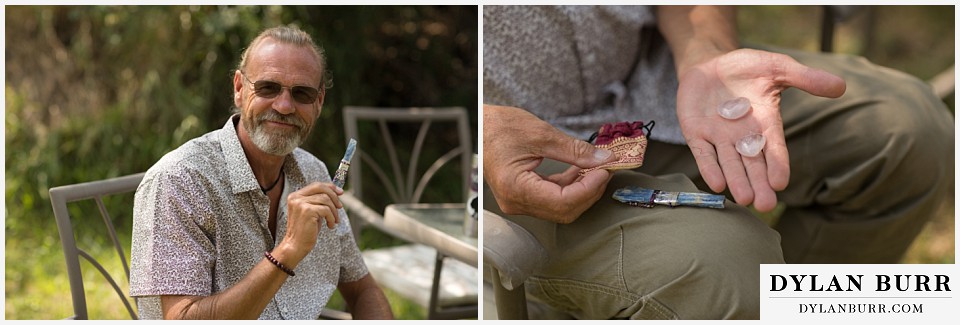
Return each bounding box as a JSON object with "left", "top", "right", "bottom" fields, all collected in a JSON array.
[{"left": 657, "top": 6, "right": 740, "bottom": 77}]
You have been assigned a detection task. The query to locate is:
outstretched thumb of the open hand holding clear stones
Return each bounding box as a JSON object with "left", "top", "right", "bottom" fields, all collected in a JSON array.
[{"left": 780, "top": 55, "right": 847, "bottom": 98}]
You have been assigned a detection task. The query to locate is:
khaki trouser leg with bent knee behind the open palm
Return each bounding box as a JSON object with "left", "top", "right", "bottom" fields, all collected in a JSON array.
[{"left": 638, "top": 49, "right": 954, "bottom": 263}]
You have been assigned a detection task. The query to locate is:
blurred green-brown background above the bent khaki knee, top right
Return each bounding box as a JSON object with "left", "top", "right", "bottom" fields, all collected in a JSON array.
[{"left": 737, "top": 5, "right": 956, "bottom": 112}]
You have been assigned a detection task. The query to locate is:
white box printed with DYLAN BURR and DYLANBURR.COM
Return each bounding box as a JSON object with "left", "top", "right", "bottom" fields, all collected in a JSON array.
[{"left": 760, "top": 264, "right": 960, "bottom": 320}]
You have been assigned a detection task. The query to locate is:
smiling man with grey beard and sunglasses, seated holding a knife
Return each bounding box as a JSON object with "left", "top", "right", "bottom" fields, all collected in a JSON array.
[{"left": 130, "top": 27, "right": 392, "bottom": 319}]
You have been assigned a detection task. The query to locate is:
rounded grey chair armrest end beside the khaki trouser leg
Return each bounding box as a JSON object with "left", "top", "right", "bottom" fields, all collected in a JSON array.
[{"left": 483, "top": 210, "right": 548, "bottom": 290}]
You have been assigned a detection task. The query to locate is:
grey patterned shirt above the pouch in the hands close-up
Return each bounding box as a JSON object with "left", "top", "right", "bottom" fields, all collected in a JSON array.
[{"left": 483, "top": 6, "right": 685, "bottom": 143}]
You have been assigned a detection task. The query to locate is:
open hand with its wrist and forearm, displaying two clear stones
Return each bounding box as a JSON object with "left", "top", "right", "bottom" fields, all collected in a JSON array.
[{"left": 657, "top": 6, "right": 846, "bottom": 211}]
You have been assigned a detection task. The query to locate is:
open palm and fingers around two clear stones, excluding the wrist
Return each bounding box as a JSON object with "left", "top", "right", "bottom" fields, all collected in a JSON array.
[{"left": 677, "top": 49, "right": 846, "bottom": 211}]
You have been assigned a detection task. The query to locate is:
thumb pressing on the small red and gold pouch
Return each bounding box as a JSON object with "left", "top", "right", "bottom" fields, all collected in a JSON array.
[{"left": 541, "top": 130, "right": 617, "bottom": 168}]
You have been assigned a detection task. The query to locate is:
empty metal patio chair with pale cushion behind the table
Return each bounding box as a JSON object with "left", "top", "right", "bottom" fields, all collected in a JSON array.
[{"left": 340, "top": 106, "right": 479, "bottom": 319}]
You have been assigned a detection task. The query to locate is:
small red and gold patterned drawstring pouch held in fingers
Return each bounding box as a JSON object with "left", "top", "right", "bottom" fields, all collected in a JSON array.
[{"left": 580, "top": 121, "right": 654, "bottom": 175}]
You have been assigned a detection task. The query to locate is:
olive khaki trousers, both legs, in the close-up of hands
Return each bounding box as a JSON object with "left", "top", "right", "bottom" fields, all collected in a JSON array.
[{"left": 484, "top": 49, "right": 954, "bottom": 319}]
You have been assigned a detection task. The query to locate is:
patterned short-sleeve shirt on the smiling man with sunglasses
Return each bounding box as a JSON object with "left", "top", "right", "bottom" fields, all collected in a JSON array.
[{"left": 130, "top": 115, "right": 367, "bottom": 319}]
